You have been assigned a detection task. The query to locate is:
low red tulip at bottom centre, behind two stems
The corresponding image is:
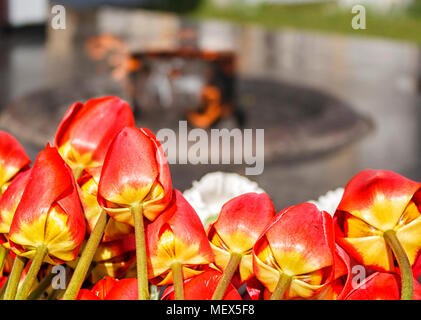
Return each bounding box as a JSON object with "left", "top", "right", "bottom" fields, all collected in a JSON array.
[{"left": 162, "top": 269, "right": 241, "bottom": 300}]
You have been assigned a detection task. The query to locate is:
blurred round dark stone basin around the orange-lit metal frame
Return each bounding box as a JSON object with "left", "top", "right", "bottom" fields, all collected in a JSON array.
[{"left": 0, "top": 78, "right": 372, "bottom": 163}]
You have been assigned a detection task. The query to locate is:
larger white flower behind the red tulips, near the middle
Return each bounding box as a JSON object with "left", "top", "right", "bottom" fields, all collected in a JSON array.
[{"left": 183, "top": 171, "right": 265, "bottom": 228}]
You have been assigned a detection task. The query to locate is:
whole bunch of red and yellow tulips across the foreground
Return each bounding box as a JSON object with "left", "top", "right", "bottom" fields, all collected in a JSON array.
[{"left": 0, "top": 97, "right": 421, "bottom": 300}]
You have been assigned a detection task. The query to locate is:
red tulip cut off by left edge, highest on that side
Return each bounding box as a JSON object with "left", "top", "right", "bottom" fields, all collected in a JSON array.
[{"left": 0, "top": 131, "right": 31, "bottom": 195}]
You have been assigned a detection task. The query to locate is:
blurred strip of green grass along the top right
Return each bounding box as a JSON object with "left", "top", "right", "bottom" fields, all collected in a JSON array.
[{"left": 191, "top": 0, "right": 421, "bottom": 44}]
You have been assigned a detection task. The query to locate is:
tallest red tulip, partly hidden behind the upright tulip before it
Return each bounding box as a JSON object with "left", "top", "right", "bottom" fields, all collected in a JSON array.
[{"left": 55, "top": 97, "right": 134, "bottom": 177}]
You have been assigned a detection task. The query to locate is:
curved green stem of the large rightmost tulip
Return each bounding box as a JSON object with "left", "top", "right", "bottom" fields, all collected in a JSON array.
[{"left": 383, "top": 230, "right": 414, "bottom": 300}]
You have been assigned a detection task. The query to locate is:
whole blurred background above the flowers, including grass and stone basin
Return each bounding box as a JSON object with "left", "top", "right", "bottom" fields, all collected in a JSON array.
[{"left": 0, "top": 0, "right": 421, "bottom": 210}]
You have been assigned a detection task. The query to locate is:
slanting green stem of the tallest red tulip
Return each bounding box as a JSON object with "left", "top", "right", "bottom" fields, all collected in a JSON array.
[{"left": 63, "top": 210, "right": 108, "bottom": 300}]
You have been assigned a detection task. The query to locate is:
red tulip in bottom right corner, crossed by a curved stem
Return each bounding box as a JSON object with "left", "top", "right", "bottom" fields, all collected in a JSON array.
[{"left": 345, "top": 272, "right": 421, "bottom": 300}]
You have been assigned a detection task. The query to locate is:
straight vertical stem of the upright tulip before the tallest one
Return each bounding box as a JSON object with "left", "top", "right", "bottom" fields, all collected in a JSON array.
[{"left": 130, "top": 204, "right": 149, "bottom": 300}]
